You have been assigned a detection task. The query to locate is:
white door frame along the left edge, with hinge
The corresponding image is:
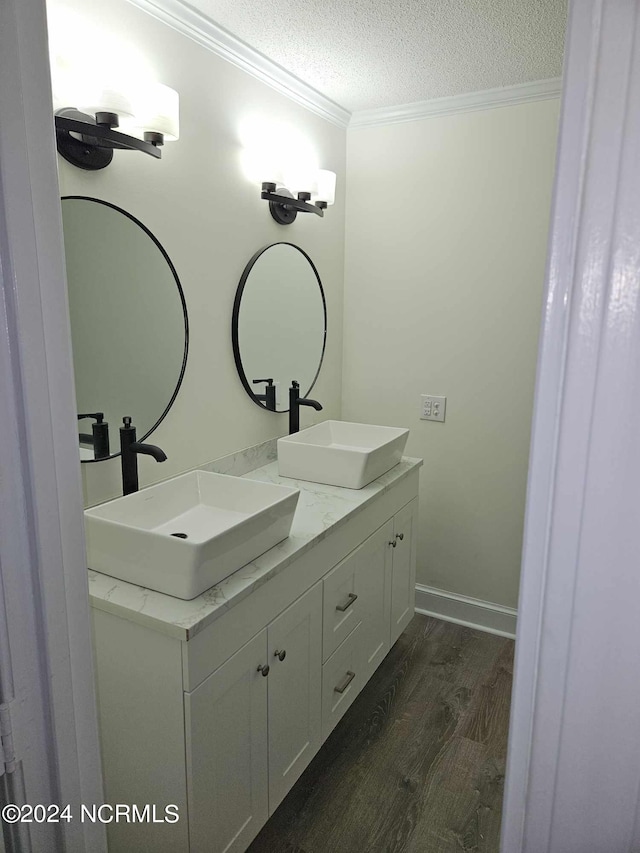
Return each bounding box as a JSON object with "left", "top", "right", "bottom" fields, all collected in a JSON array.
[{"left": 0, "top": 0, "right": 106, "bottom": 853}]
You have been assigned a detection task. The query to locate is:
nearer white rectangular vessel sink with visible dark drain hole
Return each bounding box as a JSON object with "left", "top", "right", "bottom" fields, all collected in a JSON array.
[{"left": 84, "top": 471, "right": 300, "bottom": 599}]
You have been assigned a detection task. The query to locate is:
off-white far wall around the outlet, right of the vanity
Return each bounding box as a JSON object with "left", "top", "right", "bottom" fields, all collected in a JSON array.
[{"left": 342, "top": 99, "right": 559, "bottom": 607}]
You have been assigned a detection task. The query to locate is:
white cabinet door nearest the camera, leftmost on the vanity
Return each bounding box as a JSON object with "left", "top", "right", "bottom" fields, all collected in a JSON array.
[{"left": 185, "top": 629, "right": 269, "bottom": 853}]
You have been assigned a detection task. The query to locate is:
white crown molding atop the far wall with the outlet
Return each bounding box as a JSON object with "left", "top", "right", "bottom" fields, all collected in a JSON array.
[{"left": 349, "top": 77, "right": 562, "bottom": 129}]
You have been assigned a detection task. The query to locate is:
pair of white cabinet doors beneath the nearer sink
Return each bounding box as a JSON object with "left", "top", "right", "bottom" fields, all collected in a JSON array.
[{"left": 185, "top": 583, "right": 322, "bottom": 853}]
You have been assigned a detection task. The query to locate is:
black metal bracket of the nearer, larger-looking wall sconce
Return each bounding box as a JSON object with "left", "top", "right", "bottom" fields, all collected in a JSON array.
[{"left": 55, "top": 108, "right": 162, "bottom": 172}]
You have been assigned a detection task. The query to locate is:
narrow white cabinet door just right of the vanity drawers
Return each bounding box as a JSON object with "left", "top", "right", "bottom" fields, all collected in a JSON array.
[{"left": 355, "top": 519, "right": 398, "bottom": 684}]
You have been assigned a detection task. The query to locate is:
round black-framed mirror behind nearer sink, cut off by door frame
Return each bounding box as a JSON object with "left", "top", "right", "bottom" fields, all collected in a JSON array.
[{"left": 62, "top": 196, "right": 189, "bottom": 462}]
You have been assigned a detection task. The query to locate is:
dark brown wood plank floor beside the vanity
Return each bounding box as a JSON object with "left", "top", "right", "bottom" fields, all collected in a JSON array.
[{"left": 249, "top": 615, "right": 514, "bottom": 853}]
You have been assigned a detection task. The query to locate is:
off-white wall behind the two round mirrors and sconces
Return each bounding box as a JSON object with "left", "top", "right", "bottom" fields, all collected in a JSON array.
[{"left": 49, "top": 0, "right": 345, "bottom": 505}]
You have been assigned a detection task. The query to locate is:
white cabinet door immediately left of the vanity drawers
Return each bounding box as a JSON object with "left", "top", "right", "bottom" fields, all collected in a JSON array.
[{"left": 266, "top": 582, "right": 322, "bottom": 814}]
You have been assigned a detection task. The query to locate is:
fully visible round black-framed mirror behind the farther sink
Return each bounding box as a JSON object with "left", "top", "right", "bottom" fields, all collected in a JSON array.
[{"left": 232, "top": 243, "right": 327, "bottom": 412}]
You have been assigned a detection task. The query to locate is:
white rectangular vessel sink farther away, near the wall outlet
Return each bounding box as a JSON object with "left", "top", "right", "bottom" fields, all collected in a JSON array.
[{"left": 278, "top": 421, "right": 409, "bottom": 489}]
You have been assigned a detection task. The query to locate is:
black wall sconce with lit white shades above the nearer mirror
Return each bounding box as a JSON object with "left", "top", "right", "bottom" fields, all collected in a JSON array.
[{"left": 55, "top": 83, "right": 179, "bottom": 171}]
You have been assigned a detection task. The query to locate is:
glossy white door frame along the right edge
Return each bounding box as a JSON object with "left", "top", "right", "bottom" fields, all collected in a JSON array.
[{"left": 501, "top": 0, "right": 640, "bottom": 853}]
